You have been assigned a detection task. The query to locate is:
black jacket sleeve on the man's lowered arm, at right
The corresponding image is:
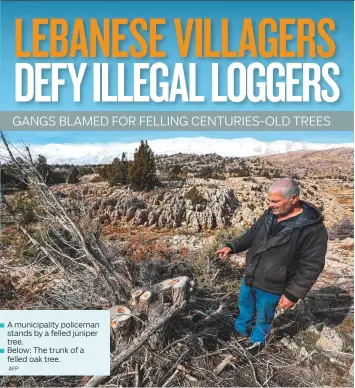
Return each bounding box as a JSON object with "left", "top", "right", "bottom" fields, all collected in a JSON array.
[{"left": 285, "top": 227, "right": 328, "bottom": 302}]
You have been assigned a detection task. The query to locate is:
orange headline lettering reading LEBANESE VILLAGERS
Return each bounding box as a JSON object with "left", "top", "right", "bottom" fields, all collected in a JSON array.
[{"left": 15, "top": 18, "right": 336, "bottom": 59}]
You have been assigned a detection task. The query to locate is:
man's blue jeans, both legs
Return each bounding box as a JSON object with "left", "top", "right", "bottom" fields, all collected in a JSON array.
[{"left": 234, "top": 279, "right": 280, "bottom": 344}]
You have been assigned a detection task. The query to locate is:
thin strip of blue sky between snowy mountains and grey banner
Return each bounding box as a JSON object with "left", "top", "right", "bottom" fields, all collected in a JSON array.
[{"left": 7, "top": 131, "right": 354, "bottom": 144}]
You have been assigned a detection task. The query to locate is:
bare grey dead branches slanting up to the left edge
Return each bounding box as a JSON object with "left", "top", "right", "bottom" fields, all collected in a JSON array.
[{"left": 1, "top": 132, "right": 132, "bottom": 302}]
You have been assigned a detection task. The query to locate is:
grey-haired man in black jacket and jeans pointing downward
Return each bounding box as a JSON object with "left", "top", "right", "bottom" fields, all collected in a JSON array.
[{"left": 216, "top": 178, "right": 328, "bottom": 354}]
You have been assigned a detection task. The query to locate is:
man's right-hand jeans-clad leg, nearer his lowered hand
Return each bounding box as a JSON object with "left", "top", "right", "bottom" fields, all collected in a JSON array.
[{"left": 250, "top": 288, "right": 280, "bottom": 344}]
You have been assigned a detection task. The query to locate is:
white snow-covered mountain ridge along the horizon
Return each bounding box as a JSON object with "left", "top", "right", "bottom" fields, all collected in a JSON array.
[{"left": 2, "top": 137, "right": 354, "bottom": 164}]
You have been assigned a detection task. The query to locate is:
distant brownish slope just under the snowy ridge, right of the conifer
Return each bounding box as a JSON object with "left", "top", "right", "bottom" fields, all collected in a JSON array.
[{"left": 157, "top": 148, "right": 354, "bottom": 181}]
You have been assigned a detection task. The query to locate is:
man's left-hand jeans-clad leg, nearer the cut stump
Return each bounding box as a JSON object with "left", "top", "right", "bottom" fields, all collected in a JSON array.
[{"left": 234, "top": 279, "right": 256, "bottom": 336}]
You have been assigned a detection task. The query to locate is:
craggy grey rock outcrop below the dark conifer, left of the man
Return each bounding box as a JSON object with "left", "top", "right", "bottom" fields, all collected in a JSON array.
[{"left": 56, "top": 183, "right": 239, "bottom": 232}]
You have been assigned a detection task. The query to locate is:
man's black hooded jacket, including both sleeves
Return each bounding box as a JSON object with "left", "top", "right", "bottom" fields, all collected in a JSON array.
[{"left": 227, "top": 201, "right": 328, "bottom": 302}]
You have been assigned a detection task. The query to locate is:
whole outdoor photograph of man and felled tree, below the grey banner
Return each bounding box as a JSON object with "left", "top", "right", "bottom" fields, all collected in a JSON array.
[{"left": 0, "top": 131, "right": 354, "bottom": 387}]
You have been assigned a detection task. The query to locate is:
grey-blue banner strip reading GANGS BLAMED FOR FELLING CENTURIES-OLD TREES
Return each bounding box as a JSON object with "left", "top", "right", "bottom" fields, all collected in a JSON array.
[{"left": 0, "top": 111, "right": 354, "bottom": 131}]
